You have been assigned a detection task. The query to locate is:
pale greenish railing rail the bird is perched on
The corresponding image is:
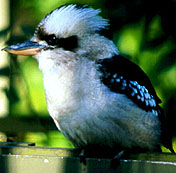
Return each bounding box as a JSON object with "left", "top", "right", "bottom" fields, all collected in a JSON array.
[{"left": 0, "top": 143, "right": 176, "bottom": 173}]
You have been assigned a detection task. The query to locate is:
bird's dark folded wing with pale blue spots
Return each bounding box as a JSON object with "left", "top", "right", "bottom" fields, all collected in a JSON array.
[{"left": 97, "top": 55, "right": 161, "bottom": 115}]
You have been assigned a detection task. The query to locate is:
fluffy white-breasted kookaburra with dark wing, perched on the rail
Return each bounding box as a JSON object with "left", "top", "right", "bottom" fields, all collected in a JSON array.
[{"left": 2, "top": 4, "right": 174, "bottom": 159}]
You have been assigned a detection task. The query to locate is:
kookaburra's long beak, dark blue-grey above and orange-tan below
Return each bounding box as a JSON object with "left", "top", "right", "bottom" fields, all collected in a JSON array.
[{"left": 2, "top": 40, "right": 46, "bottom": 56}]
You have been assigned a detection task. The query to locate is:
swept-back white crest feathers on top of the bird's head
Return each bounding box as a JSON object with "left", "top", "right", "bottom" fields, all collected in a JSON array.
[{"left": 39, "top": 5, "right": 109, "bottom": 37}]
